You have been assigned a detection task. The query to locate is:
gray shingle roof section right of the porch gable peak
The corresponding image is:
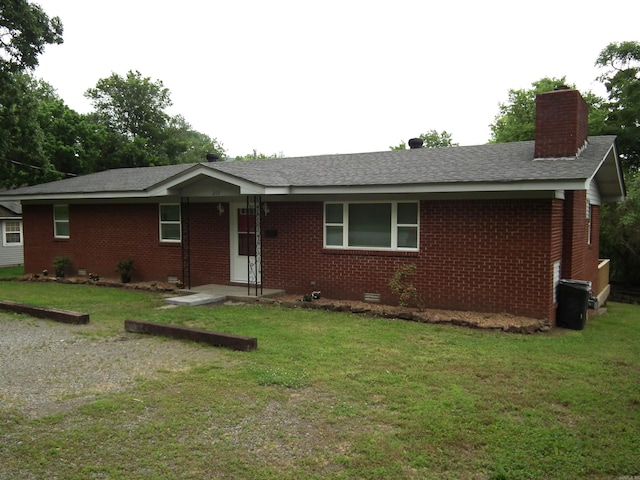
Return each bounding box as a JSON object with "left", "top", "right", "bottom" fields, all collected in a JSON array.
[{"left": 210, "top": 136, "right": 615, "bottom": 187}]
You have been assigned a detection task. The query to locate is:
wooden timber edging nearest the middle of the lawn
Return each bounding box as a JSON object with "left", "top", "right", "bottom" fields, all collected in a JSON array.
[{"left": 124, "top": 320, "right": 258, "bottom": 352}]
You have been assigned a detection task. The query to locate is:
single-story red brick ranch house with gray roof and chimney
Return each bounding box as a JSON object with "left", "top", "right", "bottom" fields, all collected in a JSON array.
[{"left": 0, "top": 89, "right": 625, "bottom": 322}]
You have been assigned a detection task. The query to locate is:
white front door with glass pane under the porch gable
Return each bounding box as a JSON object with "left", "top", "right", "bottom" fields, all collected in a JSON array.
[{"left": 229, "top": 203, "right": 261, "bottom": 285}]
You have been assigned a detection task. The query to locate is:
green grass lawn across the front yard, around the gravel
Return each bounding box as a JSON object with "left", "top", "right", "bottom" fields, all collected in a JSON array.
[{"left": 0, "top": 282, "right": 640, "bottom": 479}]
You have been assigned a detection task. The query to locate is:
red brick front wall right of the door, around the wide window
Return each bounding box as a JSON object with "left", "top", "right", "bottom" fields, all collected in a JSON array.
[{"left": 263, "top": 200, "right": 561, "bottom": 318}]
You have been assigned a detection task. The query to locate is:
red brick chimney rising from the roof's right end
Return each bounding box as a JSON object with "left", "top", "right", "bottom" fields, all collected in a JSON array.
[{"left": 535, "top": 87, "right": 589, "bottom": 158}]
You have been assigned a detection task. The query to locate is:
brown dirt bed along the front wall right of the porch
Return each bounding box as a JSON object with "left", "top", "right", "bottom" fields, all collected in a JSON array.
[{"left": 270, "top": 295, "right": 551, "bottom": 334}]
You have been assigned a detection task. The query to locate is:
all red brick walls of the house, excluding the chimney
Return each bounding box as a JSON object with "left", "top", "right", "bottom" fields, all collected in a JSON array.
[{"left": 23, "top": 192, "right": 600, "bottom": 321}]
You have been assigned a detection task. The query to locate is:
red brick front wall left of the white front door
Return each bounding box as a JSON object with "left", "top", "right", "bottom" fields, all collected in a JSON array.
[{"left": 23, "top": 203, "right": 229, "bottom": 285}]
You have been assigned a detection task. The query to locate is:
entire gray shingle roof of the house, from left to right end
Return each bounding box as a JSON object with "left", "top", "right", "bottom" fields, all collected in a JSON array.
[{"left": 0, "top": 136, "right": 615, "bottom": 197}]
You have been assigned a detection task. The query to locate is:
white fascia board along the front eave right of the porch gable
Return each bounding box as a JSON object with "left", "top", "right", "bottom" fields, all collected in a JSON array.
[{"left": 289, "top": 179, "right": 587, "bottom": 195}]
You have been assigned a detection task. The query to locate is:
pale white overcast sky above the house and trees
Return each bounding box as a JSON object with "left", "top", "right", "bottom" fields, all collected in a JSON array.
[{"left": 35, "top": 0, "right": 640, "bottom": 157}]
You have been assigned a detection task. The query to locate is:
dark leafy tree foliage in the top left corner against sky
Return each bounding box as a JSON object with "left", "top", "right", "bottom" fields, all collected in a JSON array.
[{"left": 0, "top": 0, "right": 62, "bottom": 78}]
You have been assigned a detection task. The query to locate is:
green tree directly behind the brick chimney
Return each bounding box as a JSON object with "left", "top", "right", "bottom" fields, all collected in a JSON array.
[{"left": 489, "top": 77, "right": 607, "bottom": 143}]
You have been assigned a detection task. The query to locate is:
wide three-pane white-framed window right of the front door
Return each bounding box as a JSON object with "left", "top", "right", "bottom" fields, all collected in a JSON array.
[{"left": 324, "top": 202, "right": 419, "bottom": 251}]
